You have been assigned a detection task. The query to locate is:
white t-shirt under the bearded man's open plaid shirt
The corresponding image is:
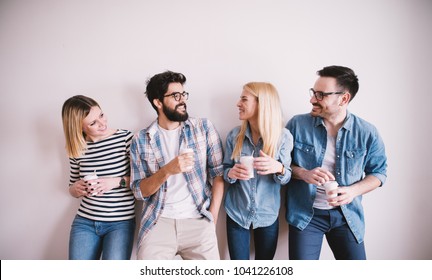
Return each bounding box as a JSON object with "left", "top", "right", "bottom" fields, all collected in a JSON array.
[{"left": 159, "top": 126, "right": 201, "bottom": 219}]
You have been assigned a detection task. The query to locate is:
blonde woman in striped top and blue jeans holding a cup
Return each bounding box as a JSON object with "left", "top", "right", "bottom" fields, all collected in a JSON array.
[{"left": 62, "top": 95, "right": 135, "bottom": 259}]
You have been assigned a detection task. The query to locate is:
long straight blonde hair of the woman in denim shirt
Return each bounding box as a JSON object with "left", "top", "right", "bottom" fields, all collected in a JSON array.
[{"left": 231, "top": 82, "right": 283, "bottom": 159}]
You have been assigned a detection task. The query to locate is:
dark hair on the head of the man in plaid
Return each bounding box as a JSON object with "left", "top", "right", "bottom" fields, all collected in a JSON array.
[{"left": 145, "top": 71, "right": 186, "bottom": 112}]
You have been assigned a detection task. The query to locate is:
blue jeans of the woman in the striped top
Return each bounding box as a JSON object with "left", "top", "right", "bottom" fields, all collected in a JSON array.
[{"left": 69, "top": 215, "right": 135, "bottom": 260}]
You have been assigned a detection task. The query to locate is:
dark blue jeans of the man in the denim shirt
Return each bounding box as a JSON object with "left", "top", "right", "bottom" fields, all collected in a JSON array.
[{"left": 288, "top": 207, "right": 366, "bottom": 260}]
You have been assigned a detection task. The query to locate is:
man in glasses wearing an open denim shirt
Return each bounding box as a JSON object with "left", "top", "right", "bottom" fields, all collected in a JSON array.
[{"left": 286, "top": 66, "right": 387, "bottom": 260}]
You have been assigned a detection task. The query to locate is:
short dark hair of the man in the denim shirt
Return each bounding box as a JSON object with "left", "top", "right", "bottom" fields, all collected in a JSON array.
[{"left": 317, "top": 65, "right": 359, "bottom": 102}]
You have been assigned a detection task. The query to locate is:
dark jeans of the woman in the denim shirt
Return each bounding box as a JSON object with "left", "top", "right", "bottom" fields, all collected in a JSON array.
[{"left": 227, "top": 215, "right": 279, "bottom": 260}]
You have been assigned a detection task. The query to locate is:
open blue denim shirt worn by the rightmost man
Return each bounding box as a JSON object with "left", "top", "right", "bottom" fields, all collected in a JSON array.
[{"left": 286, "top": 112, "right": 387, "bottom": 243}]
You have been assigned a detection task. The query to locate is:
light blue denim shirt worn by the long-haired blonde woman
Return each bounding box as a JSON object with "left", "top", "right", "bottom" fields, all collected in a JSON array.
[{"left": 223, "top": 126, "right": 293, "bottom": 229}]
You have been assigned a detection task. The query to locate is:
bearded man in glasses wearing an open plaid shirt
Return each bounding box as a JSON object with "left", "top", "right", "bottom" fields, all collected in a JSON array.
[{"left": 130, "top": 71, "right": 224, "bottom": 260}]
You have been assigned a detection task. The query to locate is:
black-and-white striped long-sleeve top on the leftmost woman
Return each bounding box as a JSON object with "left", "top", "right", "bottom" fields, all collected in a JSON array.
[{"left": 69, "top": 129, "right": 135, "bottom": 222}]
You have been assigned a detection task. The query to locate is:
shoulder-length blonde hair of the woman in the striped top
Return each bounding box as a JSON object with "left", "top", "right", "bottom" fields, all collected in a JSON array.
[{"left": 62, "top": 95, "right": 100, "bottom": 158}]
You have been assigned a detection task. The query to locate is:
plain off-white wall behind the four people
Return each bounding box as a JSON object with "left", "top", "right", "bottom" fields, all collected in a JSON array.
[{"left": 0, "top": 0, "right": 432, "bottom": 260}]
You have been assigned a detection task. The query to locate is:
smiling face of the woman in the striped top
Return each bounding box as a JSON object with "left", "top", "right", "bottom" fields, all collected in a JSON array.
[{"left": 82, "top": 106, "right": 110, "bottom": 142}]
